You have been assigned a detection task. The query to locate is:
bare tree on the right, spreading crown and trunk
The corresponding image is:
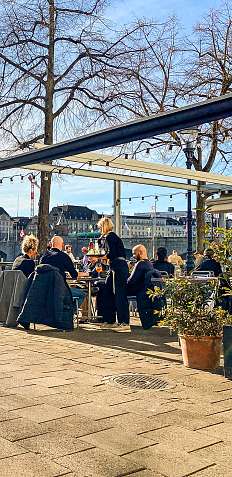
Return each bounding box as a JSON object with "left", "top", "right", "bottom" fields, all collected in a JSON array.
[{"left": 120, "top": 3, "right": 232, "bottom": 252}]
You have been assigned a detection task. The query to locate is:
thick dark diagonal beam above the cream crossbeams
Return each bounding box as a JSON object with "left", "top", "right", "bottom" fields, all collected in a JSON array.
[{"left": 0, "top": 94, "right": 232, "bottom": 170}]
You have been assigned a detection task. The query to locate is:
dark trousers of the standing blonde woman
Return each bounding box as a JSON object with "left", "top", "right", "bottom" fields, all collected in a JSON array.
[{"left": 97, "top": 259, "right": 129, "bottom": 324}]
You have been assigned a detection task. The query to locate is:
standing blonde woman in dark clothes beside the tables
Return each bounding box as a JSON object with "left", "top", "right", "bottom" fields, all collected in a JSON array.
[{"left": 97, "top": 217, "right": 130, "bottom": 331}]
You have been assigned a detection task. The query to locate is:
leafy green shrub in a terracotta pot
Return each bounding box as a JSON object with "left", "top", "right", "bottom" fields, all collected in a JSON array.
[{"left": 148, "top": 277, "right": 232, "bottom": 369}]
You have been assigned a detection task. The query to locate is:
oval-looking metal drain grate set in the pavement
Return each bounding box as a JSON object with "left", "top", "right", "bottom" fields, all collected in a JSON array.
[{"left": 103, "top": 373, "right": 174, "bottom": 391}]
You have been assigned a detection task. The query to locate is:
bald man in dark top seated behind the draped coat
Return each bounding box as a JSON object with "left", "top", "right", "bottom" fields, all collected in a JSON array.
[{"left": 40, "top": 235, "right": 86, "bottom": 306}]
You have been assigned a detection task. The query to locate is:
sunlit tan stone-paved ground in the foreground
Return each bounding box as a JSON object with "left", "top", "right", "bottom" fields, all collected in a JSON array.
[{"left": 0, "top": 325, "right": 232, "bottom": 477}]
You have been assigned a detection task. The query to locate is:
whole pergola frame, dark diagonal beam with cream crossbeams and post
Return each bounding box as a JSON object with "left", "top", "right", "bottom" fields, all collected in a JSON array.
[{"left": 0, "top": 94, "right": 232, "bottom": 238}]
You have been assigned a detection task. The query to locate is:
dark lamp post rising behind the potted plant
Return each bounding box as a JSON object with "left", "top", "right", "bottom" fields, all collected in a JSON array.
[{"left": 184, "top": 141, "right": 194, "bottom": 273}]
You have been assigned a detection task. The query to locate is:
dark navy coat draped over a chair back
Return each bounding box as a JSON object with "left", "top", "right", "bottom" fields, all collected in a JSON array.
[{"left": 17, "top": 264, "right": 73, "bottom": 331}]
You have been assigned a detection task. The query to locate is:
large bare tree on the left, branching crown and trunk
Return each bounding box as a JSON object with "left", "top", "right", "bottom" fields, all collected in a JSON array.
[{"left": 0, "top": 0, "right": 174, "bottom": 249}]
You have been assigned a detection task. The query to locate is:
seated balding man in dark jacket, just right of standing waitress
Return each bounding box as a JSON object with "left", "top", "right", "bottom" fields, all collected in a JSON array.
[{"left": 127, "top": 244, "right": 161, "bottom": 329}]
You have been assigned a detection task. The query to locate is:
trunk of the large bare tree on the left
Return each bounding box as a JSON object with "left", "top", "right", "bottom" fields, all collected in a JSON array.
[{"left": 38, "top": 0, "right": 55, "bottom": 253}]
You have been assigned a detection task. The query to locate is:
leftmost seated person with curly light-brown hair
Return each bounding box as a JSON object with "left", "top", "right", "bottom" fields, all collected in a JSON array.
[{"left": 12, "top": 235, "right": 39, "bottom": 278}]
